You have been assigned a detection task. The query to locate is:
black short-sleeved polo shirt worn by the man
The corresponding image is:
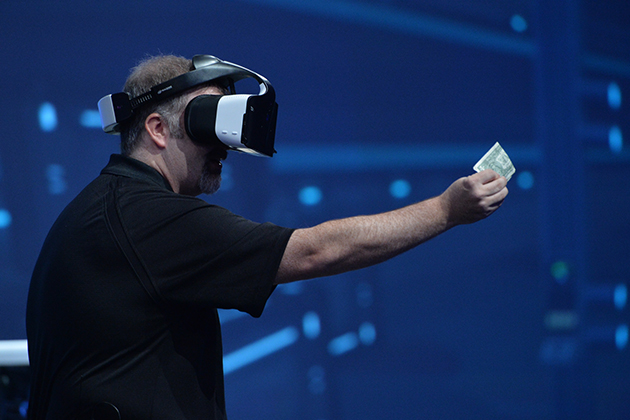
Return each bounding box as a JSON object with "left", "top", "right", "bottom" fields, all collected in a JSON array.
[{"left": 26, "top": 155, "right": 292, "bottom": 420}]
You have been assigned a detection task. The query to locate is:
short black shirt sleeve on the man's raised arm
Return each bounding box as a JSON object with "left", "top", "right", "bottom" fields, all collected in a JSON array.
[{"left": 120, "top": 191, "right": 293, "bottom": 317}]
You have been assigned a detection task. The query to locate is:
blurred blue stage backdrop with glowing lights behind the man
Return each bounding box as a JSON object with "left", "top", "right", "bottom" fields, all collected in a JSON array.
[{"left": 0, "top": 0, "right": 630, "bottom": 420}]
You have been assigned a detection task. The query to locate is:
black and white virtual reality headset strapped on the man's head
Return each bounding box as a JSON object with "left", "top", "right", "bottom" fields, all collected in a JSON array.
[{"left": 98, "top": 55, "right": 278, "bottom": 157}]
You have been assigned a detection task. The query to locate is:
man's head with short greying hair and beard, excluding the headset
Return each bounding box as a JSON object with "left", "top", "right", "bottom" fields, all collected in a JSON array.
[{"left": 121, "top": 55, "right": 227, "bottom": 195}]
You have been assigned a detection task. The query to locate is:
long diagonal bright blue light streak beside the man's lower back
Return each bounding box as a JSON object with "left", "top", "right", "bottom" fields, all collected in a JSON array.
[{"left": 223, "top": 327, "right": 300, "bottom": 375}]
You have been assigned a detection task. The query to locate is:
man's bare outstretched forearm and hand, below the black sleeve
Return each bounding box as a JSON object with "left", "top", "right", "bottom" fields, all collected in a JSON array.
[{"left": 276, "top": 169, "right": 508, "bottom": 283}]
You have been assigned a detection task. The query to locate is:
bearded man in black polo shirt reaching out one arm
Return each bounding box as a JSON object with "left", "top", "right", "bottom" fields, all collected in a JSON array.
[{"left": 27, "top": 56, "right": 507, "bottom": 420}]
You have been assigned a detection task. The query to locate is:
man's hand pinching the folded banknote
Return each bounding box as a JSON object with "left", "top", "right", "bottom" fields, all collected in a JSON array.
[{"left": 439, "top": 169, "right": 508, "bottom": 227}]
